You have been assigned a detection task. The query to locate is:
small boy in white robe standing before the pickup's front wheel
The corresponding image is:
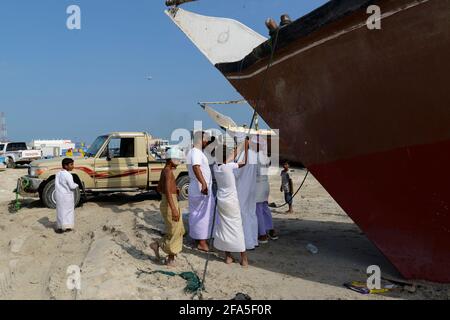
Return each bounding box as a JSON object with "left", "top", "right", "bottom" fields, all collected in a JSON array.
[{"left": 55, "top": 158, "right": 79, "bottom": 233}]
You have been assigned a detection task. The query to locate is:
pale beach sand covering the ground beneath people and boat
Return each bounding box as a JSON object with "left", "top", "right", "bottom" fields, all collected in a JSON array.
[{"left": 0, "top": 169, "right": 450, "bottom": 300}]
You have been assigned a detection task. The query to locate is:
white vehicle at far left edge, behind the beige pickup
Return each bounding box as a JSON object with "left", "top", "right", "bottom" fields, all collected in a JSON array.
[{"left": 0, "top": 142, "right": 42, "bottom": 168}]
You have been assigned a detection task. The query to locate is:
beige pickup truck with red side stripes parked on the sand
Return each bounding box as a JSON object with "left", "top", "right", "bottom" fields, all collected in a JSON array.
[{"left": 18, "top": 132, "right": 189, "bottom": 209}]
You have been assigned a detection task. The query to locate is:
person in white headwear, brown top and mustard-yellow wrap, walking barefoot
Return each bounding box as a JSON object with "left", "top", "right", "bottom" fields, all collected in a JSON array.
[{"left": 150, "top": 148, "right": 185, "bottom": 267}]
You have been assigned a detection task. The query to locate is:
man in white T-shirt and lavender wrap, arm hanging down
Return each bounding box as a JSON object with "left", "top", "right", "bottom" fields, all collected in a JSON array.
[{"left": 186, "top": 131, "right": 215, "bottom": 252}]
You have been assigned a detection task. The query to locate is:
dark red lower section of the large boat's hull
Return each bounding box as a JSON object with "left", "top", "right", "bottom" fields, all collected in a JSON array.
[{"left": 310, "top": 140, "right": 450, "bottom": 282}]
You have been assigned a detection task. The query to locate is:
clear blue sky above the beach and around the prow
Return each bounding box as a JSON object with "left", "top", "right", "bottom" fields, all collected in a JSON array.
[{"left": 0, "top": 0, "right": 327, "bottom": 143}]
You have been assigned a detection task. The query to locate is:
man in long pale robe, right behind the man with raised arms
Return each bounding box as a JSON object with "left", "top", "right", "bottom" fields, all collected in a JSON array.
[{"left": 234, "top": 135, "right": 259, "bottom": 250}]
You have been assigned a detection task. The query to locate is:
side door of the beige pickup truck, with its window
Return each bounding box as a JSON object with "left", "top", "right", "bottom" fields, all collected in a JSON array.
[{"left": 95, "top": 137, "right": 143, "bottom": 189}]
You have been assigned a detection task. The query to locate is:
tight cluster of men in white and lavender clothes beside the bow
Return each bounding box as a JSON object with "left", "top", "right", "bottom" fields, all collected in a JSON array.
[{"left": 187, "top": 132, "right": 277, "bottom": 266}]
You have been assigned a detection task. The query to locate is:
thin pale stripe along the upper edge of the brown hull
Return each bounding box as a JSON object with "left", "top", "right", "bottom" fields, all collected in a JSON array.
[{"left": 227, "top": 0, "right": 430, "bottom": 80}]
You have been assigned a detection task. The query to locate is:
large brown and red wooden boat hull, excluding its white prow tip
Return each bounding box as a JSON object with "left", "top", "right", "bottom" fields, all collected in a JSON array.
[{"left": 217, "top": 0, "right": 450, "bottom": 282}]
